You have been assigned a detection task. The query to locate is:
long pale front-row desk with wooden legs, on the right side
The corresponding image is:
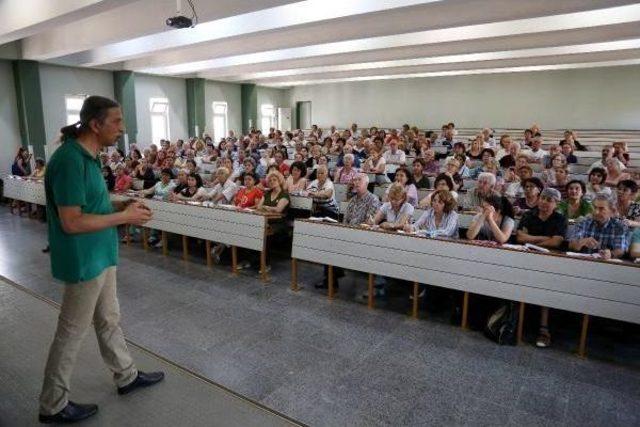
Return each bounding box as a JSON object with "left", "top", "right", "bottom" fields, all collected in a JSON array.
[{"left": 291, "top": 220, "right": 640, "bottom": 354}]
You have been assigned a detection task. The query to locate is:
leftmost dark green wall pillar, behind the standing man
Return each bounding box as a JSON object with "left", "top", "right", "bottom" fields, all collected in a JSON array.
[{"left": 13, "top": 60, "right": 47, "bottom": 158}]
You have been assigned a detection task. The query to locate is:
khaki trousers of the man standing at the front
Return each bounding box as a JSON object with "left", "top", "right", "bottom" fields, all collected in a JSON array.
[{"left": 40, "top": 267, "right": 138, "bottom": 415}]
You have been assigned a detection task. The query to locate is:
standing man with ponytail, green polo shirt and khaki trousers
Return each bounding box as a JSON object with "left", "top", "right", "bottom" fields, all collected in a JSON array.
[{"left": 39, "top": 96, "right": 164, "bottom": 423}]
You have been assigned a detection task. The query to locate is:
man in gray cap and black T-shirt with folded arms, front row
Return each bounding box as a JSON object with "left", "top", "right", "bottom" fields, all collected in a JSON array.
[{"left": 516, "top": 188, "right": 567, "bottom": 348}]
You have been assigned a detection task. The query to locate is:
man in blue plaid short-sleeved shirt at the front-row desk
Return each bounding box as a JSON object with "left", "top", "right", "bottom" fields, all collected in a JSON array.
[{"left": 569, "top": 194, "right": 629, "bottom": 259}]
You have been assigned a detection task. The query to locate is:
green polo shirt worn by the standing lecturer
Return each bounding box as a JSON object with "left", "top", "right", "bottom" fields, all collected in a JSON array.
[{"left": 44, "top": 139, "right": 118, "bottom": 283}]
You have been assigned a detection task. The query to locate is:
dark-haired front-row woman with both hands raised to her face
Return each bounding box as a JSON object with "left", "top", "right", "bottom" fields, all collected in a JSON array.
[{"left": 467, "top": 194, "right": 515, "bottom": 244}]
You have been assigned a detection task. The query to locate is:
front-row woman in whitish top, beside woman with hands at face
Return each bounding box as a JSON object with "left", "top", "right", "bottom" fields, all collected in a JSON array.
[{"left": 404, "top": 190, "right": 458, "bottom": 237}]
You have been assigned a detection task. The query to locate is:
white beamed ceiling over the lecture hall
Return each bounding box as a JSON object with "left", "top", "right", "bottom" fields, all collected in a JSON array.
[{"left": 0, "top": 0, "right": 640, "bottom": 87}]
